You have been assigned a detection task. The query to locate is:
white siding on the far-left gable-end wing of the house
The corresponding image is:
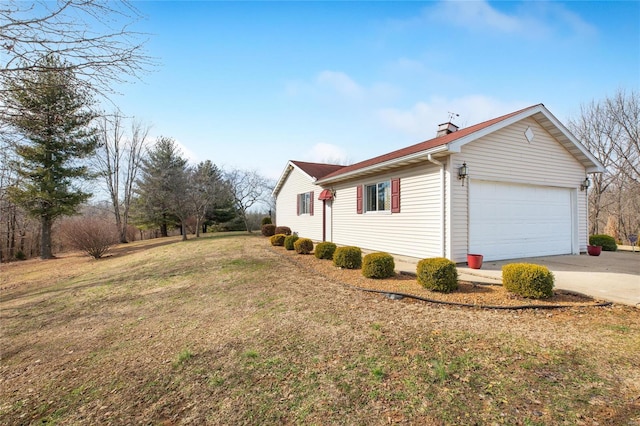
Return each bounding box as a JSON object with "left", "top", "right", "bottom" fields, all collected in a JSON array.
[{"left": 276, "top": 167, "right": 322, "bottom": 241}]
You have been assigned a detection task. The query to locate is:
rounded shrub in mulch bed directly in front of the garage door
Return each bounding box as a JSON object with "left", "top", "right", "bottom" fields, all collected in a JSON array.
[{"left": 502, "top": 263, "right": 553, "bottom": 299}]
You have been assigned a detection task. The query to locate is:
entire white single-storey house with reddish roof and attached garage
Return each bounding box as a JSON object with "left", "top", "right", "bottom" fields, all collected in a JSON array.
[{"left": 273, "top": 104, "right": 603, "bottom": 262}]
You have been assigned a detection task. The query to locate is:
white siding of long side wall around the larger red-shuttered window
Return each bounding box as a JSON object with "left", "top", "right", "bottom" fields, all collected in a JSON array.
[{"left": 332, "top": 163, "right": 442, "bottom": 258}]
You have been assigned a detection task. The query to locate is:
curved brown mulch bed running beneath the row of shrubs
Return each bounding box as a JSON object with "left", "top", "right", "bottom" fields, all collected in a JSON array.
[{"left": 267, "top": 241, "right": 611, "bottom": 309}]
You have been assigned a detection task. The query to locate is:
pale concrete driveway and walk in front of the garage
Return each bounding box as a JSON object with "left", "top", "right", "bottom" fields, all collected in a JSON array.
[{"left": 457, "top": 251, "right": 640, "bottom": 308}]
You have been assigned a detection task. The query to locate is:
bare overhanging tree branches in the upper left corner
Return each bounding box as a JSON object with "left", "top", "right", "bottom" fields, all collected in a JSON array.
[{"left": 0, "top": 0, "right": 154, "bottom": 99}]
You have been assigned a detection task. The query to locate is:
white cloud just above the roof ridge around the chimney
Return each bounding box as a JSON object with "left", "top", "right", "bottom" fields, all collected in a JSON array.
[{"left": 377, "top": 95, "right": 530, "bottom": 142}]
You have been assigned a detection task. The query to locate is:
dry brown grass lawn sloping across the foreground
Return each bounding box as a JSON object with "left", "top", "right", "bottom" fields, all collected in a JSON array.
[{"left": 0, "top": 234, "right": 640, "bottom": 425}]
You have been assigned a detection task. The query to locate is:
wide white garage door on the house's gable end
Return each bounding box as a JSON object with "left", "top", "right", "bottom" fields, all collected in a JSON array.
[{"left": 469, "top": 181, "right": 573, "bottom": 260}]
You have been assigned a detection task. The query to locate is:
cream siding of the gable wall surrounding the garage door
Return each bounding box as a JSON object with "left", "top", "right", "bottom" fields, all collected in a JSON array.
[{"left": 448, "top": 118, "right": 587, "bottom": 262}]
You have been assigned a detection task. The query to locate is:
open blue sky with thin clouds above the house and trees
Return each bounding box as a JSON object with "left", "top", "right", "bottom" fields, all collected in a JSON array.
[{"left": 113, "top": 1, "right": 640, "bottom": 179}]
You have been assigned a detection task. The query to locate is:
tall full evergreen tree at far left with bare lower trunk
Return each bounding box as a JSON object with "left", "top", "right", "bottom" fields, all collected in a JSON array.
[{"left": 3, "top": 55, "right": 97, "bottom": 259}]
